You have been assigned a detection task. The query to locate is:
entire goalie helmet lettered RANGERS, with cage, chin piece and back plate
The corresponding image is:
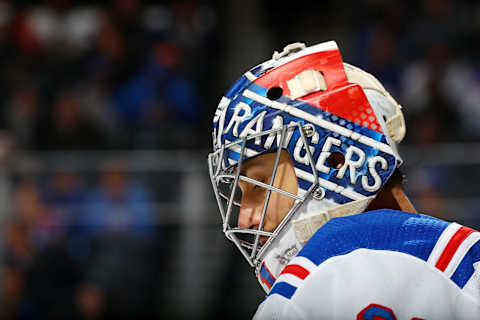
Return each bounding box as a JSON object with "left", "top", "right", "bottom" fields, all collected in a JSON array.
[{"left": 208, "top": 41, "right": 405, "bottom": 292}]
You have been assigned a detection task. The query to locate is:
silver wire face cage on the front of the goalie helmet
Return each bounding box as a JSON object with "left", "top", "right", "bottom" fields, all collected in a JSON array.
[{"left": 208, "top": 123, "right": 317, "bottom": 266}]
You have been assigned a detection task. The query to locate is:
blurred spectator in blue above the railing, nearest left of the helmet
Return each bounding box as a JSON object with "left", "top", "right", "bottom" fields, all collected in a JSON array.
[{"left": 113, "top": 43, "right": 200, "bottom": 148}]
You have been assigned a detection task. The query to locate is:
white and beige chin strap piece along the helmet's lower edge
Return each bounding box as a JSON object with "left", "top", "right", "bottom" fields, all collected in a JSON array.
[{"left": 256, "top": 196, "right": 375, "bottom": 293}]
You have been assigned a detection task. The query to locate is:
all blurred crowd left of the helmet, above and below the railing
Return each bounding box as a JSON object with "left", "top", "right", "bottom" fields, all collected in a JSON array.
[{"left": 0, "top": 0, "right": 216, "bottom": 319}]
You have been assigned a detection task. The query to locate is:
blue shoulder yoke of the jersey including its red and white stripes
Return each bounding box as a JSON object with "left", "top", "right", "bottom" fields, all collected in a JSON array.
[{"left": 269, "top": 209, "right": 480, "bottom": 299}]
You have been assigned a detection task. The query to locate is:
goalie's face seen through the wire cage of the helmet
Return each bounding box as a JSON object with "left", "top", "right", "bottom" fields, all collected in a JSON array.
[{"left": 238, "top": 150, "right": 298, "bottom": 232}]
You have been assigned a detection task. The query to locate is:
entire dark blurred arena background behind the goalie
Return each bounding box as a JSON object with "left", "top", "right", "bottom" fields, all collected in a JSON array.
[{"left": 0, "top": 0, "right": 480, "bottom": 319}]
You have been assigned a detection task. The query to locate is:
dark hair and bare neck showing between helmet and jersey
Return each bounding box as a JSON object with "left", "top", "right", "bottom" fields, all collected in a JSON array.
[{"left": 366, "top": 168, "right": 417, "bottom": 212}]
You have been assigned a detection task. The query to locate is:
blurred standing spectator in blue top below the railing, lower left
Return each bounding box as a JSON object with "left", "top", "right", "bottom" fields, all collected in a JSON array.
[{"left": 77, "top": 160, "right": 157, "bottom": 318}]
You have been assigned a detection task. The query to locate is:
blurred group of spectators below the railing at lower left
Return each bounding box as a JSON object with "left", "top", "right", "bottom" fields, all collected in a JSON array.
[{"left": 0, "top": 164, "right": 162, "bottom": 319}]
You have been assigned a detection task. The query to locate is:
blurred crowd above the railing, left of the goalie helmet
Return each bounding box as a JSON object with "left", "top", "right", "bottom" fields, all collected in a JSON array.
[{"left": 0, "top": 0, "right": 215, "bottom": 150}]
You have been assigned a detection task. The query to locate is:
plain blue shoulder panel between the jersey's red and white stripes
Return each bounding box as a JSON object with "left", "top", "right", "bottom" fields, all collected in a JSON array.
[{"left": 298, "top": 209, "right": 451, "bottom": 265}]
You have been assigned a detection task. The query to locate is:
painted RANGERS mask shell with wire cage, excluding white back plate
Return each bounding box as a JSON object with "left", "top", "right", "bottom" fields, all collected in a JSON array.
[{"left": 208, "top": 41, "right": 399, "bottom": 272}]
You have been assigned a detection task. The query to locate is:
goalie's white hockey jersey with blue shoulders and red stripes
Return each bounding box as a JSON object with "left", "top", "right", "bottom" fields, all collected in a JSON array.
[{"left": 254, "top": 209, "right": 480, "bottom": 320}]
